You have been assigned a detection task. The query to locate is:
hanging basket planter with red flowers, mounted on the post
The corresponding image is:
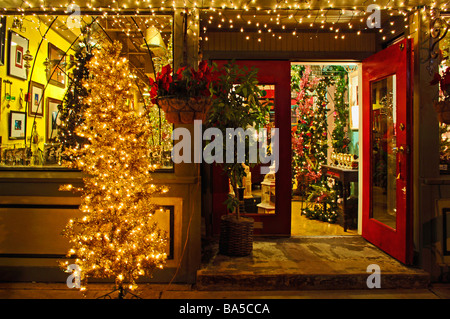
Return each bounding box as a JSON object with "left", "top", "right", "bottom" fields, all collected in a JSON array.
[{"left": 150, "top": 61, "right": 212, "bottom": 124}]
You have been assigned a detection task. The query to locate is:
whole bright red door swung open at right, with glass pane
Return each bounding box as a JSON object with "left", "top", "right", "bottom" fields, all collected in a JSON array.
[{"left": 361, "top": 39, "right": 413, "bottom": 264}]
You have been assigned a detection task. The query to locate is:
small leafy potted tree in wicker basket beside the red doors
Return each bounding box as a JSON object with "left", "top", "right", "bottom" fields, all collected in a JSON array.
[{"left": 206, "top": 62, "right": 270, "bottom": 256}]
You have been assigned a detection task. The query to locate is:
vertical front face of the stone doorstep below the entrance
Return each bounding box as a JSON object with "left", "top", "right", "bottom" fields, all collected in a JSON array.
[{"left": 195, "top": 270, "right": 430, "bottom": 291}]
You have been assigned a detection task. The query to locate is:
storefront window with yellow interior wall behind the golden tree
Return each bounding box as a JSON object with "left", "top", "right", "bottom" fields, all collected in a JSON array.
[{"left": 0, "top": 15, "right": 173, "bottom": 170}]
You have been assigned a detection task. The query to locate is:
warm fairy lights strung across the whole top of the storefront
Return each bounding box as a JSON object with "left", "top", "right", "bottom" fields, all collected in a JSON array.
[{"left": 0, "top": 0, "right": 450, "bottom": 48}]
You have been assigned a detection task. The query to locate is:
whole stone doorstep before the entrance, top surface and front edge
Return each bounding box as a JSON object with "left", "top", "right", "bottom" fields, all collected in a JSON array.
[{"left": 196, "top": 236, "right": 430, "bottom": 291}]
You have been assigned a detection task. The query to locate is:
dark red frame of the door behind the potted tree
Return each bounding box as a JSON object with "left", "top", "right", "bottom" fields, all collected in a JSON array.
[{"left": 212, "top": 60, "right": 292, "bottom": 236}]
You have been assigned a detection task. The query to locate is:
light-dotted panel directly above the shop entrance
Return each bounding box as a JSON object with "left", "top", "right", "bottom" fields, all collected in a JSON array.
[{"left": 201, "top": 4, "right": 438, "bottom": 42}]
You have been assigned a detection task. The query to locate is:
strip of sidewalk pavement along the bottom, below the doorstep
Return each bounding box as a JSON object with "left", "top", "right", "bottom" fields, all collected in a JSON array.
[{"left": 0, "top": 282, "right": 450, "bottom": 300}]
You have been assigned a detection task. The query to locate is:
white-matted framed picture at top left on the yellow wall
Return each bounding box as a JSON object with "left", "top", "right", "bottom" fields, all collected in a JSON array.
[{"left": 8, "top": 30, "right": 29, "bottom": 80}]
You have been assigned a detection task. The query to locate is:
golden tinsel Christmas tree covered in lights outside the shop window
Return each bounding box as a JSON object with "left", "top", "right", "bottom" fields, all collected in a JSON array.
[{"left": 61, "top": 42, "right": 167, "bottom": 297}]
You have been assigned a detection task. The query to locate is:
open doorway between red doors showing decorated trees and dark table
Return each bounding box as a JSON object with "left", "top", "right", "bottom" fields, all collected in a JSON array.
[{"left": 291, "top": 62, "right": 361, "bottom": 236}]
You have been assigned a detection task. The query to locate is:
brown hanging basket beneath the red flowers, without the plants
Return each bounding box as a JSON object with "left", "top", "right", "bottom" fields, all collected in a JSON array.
[{"left": 158, "top": 96, "right": 211, "bottom": 124}]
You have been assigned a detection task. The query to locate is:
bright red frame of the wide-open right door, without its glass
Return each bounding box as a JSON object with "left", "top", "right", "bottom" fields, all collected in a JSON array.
[{"left": 362, "top": 39, "right": 413, "bottom": 264}]
